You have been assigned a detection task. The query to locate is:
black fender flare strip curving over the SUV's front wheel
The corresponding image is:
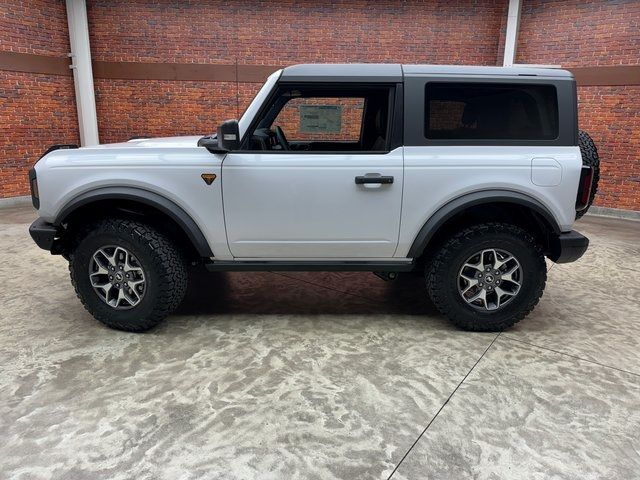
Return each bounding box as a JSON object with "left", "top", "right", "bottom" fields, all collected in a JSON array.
[{"left": 53, "top": 187, "right": 213, "bottom": 257}]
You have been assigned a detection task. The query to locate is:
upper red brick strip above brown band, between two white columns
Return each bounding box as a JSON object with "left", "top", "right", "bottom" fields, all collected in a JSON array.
[{"left": 88, "top": 0, "right": 506, "bottom": 65}]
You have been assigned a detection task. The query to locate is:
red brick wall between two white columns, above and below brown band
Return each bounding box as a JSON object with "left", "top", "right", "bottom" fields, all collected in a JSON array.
[{"left": 88, "top": 0, "right": 506, "bottom": 141}]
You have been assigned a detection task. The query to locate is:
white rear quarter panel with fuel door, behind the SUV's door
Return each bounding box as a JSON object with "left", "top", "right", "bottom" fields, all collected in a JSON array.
[{"left": 395, "top": 146, "right": 582, "bottom": 257}]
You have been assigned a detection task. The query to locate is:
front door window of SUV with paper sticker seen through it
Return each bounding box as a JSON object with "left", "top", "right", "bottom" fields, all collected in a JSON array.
[{"left": 244, "top": 85, "right": 392, "bottom": 152}]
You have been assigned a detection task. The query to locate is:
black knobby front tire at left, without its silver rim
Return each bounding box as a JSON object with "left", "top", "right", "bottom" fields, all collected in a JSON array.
[{"left": 69, "top": 218, "right": 188, "bottom": 332}]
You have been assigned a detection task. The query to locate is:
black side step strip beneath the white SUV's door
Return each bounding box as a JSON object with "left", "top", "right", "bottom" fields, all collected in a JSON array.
[{"left": 204, "top": 260, "right": 414, "bottom": 272}]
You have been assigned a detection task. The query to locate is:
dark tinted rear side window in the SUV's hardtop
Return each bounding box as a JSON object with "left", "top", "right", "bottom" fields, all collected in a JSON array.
[{"left": 424, "top": 82, "right": 558, "bottom": 140}]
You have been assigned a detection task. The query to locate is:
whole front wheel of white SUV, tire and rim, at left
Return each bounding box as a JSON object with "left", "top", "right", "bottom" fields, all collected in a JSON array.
[{"left": 69, "top": 219, "right": 187, "bottom": 332}]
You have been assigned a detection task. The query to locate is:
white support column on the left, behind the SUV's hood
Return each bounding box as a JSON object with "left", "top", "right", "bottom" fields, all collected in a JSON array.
[{"left": 66, "top": 0, "right": 99, "bottom": 146}]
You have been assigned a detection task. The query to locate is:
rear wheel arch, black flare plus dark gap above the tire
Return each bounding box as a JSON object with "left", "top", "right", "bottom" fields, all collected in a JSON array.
[{"left": 407, "top": 190, "right": 561, "bottom": 258}]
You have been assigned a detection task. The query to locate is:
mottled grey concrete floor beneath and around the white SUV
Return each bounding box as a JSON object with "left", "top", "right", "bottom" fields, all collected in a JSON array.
[{"left": 0, "top": 204, "right": 640, "bottom": 480}]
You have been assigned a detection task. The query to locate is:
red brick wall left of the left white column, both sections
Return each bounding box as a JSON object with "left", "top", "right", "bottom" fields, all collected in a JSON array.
[{"left": 0, "top": 0, "right": 79, "bottom": 197}]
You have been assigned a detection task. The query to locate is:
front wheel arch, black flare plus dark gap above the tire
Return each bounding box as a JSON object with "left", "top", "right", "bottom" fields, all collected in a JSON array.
[{"left": 53, "top": 187, "right": 213, "bottom": 257}]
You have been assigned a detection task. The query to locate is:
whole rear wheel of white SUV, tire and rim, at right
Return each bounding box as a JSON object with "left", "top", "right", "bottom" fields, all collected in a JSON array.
[{"left": 426, "top": 223, "right": 547, "bottom": 331}]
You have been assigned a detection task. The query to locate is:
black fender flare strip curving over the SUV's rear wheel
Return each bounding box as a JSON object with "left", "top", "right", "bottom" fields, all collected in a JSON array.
[{"left": 407, "top": 190, "right": 561, "bottom": 258}]
